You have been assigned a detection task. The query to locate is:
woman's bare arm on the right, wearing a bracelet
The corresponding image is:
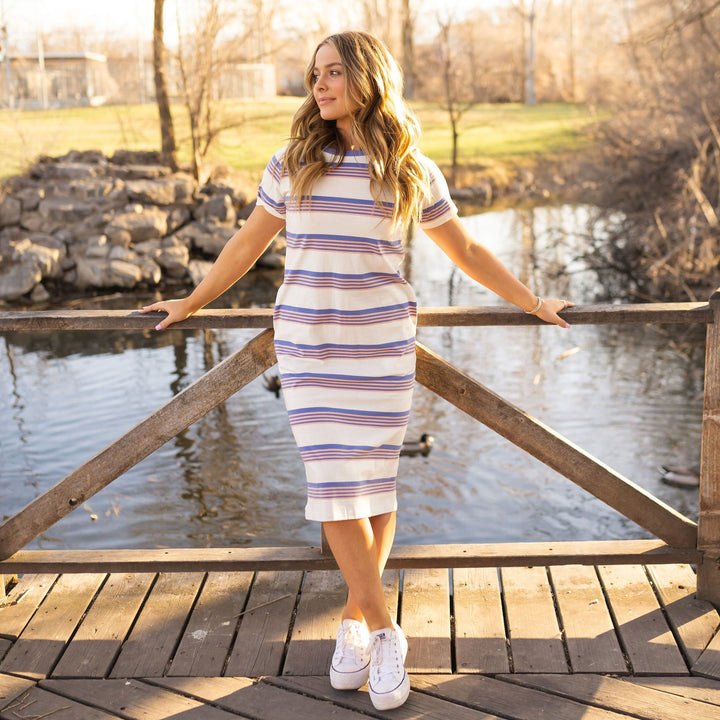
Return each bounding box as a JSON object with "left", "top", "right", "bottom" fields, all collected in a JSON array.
[{"left": 424, "top": 218, "right": 574, "bottom": 328}]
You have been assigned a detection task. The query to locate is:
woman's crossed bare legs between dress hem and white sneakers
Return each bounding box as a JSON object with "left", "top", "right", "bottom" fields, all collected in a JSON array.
[{"left": 323, "top": 513, "right": 395, "bottom": 631}]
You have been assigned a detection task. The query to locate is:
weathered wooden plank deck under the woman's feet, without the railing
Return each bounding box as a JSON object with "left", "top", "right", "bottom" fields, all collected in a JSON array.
[{"left": 0, "top": 564, "right": 720, "bottom": 720}]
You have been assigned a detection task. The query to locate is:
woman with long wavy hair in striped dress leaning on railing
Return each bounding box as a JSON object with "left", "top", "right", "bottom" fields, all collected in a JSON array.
[{"left": 142, "top": 32, "right": 572, "bottom": 710}]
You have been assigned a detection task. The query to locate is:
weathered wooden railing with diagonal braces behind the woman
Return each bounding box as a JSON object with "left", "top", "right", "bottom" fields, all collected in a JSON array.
[{"left": 0, "top": 292, "right": 720, "bottom": 606}]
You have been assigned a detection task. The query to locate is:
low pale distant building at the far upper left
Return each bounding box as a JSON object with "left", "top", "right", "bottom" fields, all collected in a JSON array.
[{"left": 0, "top": 52, "right": 117, "bottom": 110}]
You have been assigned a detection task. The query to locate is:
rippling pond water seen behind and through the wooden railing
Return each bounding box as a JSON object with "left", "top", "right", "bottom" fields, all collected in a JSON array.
[{"left": 0, "top": 206, "right": 703, "bottom": 549}]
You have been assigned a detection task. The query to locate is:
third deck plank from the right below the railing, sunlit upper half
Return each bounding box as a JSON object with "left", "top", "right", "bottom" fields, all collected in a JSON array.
[{"left": 550, "top": 565, "right": 627, "bottom": 674}]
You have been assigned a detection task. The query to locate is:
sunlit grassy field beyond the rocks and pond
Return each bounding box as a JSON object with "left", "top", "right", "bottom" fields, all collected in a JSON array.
[{"left": 0, "top": 97, "right": 597, "bottom": 181}]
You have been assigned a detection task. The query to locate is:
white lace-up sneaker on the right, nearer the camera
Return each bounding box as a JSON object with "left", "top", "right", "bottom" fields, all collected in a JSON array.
[{"left": 369, "top": 623, "right": 410, "bottom": 710}]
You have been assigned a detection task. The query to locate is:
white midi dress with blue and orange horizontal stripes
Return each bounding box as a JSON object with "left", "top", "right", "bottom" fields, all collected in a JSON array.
[{"left": 257, "top": 150, "right": 457, "bottom": 521}]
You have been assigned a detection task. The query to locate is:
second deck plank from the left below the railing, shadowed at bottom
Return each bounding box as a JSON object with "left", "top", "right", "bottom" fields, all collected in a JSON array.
[{"left": 0, "top": 574, "right": 105, "bottom": 679}]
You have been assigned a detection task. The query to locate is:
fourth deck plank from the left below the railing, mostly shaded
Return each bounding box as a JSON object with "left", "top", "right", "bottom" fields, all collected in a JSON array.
[{"left": 110, "top": 573, "right": 203, "bottom": 678}]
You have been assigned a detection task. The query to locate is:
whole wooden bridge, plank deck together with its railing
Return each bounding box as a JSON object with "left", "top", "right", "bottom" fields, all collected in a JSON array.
[{"left": 0, "top": 293, "right": 720, "bottom": 720}]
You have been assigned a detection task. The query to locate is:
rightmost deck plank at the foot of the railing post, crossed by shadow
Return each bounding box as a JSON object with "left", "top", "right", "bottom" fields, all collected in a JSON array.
[{"left": 647, "top": 565, "right": 720, "bottom": 666}]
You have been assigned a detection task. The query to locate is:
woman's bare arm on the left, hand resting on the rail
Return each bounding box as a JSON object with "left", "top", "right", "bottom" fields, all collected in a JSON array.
[{"left": 140, "top": 206, "right": 285, "bottom": 330}]
